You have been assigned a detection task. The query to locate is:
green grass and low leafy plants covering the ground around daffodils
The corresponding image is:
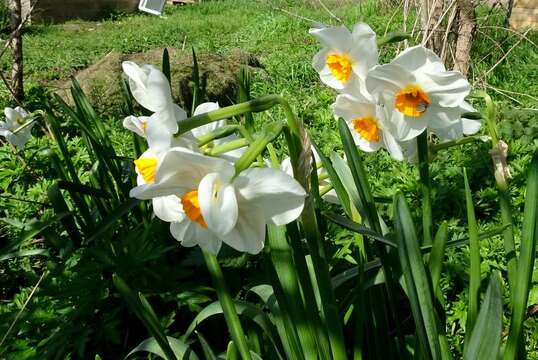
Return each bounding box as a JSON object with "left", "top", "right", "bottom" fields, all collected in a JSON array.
[{"left": 0, "top": 0, "right": 538, "bottom": 359}]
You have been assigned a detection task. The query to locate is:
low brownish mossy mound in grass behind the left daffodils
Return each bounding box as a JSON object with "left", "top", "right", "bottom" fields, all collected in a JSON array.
[{"left": 57, "top": 49, "right": 261, "bottom": 115}]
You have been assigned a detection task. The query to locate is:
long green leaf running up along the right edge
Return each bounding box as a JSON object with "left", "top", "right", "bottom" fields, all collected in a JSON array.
[{"left": 504, "top": 154, "right": 538, "bottom": 360}]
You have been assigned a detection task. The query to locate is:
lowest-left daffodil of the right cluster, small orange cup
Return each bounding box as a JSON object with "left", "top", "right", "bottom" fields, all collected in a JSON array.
[{"left": 332, "top": 94, "right": 403, "bottom": 160}]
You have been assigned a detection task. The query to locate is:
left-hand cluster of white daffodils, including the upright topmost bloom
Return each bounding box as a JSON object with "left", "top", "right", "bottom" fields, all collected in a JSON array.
[{"left": 123, "top": 62, "right": 306, "bottom": 254}]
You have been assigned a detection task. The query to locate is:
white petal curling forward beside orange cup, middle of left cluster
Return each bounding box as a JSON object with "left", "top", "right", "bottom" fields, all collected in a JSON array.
[{"left": 198, "top": 173, "right": 238, "bottom": 235}]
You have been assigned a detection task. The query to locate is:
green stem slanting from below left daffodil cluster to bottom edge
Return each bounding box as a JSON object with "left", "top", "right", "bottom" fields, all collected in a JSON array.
[{"left": 202, "top": 250, "right": 252, "bottom": 360}]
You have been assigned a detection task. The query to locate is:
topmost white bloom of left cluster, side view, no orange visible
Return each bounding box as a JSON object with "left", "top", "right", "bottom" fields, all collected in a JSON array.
[{"left": 122, "top": 61, "right": 180, "bottom": 133}]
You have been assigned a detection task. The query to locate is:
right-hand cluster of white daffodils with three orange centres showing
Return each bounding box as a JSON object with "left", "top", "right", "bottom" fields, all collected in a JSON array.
[{"left": 310, "top": 23, "right": 480, "bottom": 160}]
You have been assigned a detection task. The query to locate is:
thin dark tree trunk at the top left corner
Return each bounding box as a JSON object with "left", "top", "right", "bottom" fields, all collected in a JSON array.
[{"left": 11, "top": 0, "right": 24, "bottom": 101}]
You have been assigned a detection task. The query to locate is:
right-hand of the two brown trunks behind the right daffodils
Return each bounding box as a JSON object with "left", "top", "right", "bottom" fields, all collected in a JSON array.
[{"left": 454, "top": 0, "right": 476, "bottom": 76}]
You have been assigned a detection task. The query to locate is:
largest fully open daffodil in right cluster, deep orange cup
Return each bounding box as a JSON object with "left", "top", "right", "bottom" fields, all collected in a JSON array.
[{"left": 366, "top": 45, "right": 471, "bottom": 141}]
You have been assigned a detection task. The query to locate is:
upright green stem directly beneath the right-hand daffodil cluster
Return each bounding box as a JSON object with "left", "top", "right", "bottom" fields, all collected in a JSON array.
[{"left": 417, "top": 130, "right": 433, "bottom": 245}]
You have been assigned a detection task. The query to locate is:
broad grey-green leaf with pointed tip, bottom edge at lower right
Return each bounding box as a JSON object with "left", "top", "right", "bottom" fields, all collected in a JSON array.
[{"left": 463, "top": 272, "right": 503, "bottom": 360}]
